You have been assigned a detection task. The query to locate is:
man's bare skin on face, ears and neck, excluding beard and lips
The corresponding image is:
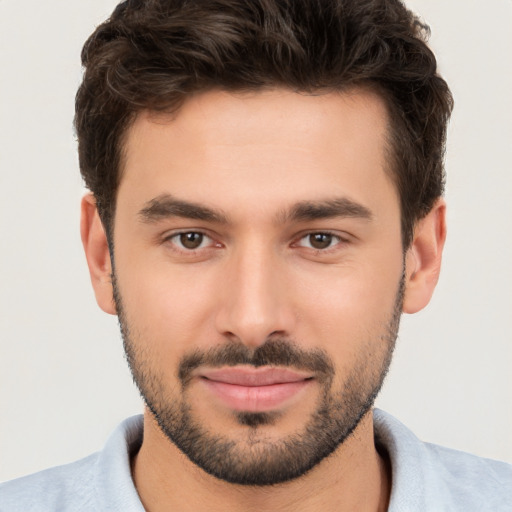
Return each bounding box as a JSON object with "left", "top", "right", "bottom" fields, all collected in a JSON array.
[{"left": 81, "top": 89, "right": 446, "bottom": 512}]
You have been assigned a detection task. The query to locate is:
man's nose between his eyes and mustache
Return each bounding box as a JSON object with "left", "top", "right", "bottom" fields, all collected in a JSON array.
[{"left": 216, "top": 244, "right": 295, "bottom": 348}]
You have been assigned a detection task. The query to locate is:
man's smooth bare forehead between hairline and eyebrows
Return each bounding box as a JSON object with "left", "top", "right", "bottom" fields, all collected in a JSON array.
[{"left": 118, "top": 89, "right": 394, "bottom": 222}]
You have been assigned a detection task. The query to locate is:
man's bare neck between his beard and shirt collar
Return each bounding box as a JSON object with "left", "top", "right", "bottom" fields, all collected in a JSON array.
[{"left": 132, "top": 411, "right": 391, "bottom": 512}]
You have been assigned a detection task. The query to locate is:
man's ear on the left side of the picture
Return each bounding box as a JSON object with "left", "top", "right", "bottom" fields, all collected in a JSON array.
[{"left": 80, "top": 194, "right": 116, "bottom": 315}]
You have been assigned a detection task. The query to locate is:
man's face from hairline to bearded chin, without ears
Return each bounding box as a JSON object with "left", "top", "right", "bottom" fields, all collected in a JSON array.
[{"left": 113, "top": 90, "right": 404, "bottom": 485}]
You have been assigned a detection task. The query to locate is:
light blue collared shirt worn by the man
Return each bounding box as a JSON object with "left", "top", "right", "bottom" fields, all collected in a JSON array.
[{"left": 0, "top": 409, "right": 512, "bottom": 512}]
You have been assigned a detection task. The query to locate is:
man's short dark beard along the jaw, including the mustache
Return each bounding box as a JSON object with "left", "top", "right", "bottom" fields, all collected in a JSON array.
[{"left": 112, "top": 272, "right": 405, "bottom": 486}]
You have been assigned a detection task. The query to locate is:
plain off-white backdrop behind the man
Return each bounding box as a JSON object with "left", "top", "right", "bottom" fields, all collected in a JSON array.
[{"left": 0, "top": 0, "right": 512, "bottom": 480}]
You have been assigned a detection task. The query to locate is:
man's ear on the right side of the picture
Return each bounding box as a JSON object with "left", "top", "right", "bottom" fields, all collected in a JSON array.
[{"left": 403, "top": 199, "right": 446, "bottom": 313}]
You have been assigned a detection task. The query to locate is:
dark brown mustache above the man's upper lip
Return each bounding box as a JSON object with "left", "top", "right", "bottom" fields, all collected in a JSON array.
[{"left": 178, "top": 339, "right": 334, "bottom": 386}]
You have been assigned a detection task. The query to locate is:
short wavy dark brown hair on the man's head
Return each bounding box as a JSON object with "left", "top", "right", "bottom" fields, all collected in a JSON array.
[{"left": 75, "top": 0, "right": 453, "bottom": 247}]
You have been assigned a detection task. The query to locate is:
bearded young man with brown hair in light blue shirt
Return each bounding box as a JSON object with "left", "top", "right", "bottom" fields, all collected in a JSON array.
[{"left": 0, "top": 0, "right": 512, "bottom": 511}]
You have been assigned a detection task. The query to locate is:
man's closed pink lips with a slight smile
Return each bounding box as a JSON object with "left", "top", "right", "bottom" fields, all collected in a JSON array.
[{"left": 198, "top": 366, "right": 314, "bottom": 412}]
